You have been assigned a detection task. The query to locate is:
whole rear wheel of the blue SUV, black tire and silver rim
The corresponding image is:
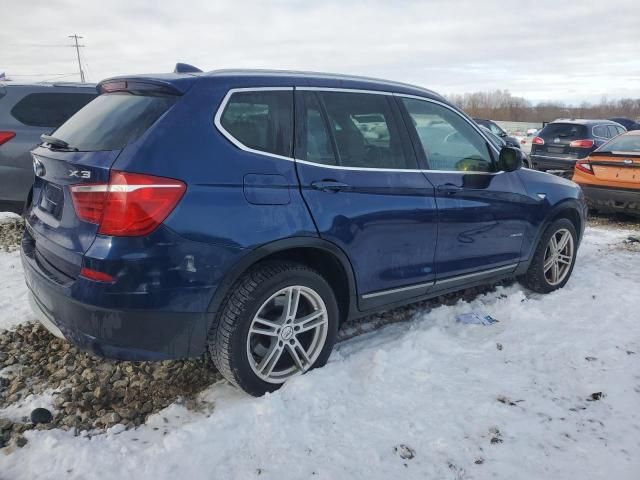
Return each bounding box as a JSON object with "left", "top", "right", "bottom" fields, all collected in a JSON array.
[{"left": 208, "top": 263, "right": 339, "bottom": 396}]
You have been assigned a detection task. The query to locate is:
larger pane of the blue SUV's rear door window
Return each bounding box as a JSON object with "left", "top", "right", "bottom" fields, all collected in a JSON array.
[{"left": 316, "top": 91, "right": 417, "bottom": 170}]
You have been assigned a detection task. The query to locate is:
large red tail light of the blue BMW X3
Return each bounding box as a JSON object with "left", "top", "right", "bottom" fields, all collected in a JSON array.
[{"left": 71, "top": 171, "right": 186, "bottom": 237}]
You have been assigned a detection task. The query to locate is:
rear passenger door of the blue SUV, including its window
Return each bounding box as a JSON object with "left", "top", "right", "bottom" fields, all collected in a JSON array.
[{"left": 295, "top": 88, "right": 437, "bottom": 309}]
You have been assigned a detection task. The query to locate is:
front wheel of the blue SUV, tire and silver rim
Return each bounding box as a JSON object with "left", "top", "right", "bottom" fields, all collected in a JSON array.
[{"left": 519, "top": 218, "right": 578, "bottom": 293}]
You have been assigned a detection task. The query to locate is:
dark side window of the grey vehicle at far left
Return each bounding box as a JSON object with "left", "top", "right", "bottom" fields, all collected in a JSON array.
[{"left": 11, "top": 92, "right": 96, "bottom": 128}]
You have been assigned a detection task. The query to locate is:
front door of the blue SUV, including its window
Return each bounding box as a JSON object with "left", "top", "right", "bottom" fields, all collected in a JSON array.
[{"left": 399, "top": 97, "right": 530, "bottom": 286}]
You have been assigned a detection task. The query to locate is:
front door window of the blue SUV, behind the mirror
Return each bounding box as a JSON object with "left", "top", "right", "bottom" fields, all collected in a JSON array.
[{"left": 402, "top": 98, "right": 494, "bottom": 172}]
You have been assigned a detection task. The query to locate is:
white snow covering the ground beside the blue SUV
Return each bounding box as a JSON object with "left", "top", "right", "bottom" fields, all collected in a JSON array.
[{"left": 0, "top": 228, "right": 640, "bottom": 480}]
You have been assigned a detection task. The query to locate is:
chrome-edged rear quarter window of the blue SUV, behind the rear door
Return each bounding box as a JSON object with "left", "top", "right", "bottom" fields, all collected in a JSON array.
[{"left": 220, "top": 90, "right": 293, "bottom": 157}]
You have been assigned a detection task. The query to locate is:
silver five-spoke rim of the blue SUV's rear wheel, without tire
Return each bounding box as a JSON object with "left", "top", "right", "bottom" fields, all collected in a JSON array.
[{"left": 247, "top": 285, "right": 329, "bottom": 383}]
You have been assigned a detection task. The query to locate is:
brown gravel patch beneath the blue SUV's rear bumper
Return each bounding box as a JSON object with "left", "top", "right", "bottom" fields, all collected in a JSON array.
[{"left": 0, "top": 323, "right": 222, "bottom": 447}]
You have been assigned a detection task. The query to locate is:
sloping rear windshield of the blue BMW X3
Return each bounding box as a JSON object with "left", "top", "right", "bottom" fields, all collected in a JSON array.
[{"left": 53, "top": 92, "right": 176, "bottom": 151}]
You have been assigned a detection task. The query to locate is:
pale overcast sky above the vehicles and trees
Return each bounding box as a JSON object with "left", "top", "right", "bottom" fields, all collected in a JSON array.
[{"left": 0, "top": 0, "right": 640, "bottom": 103}]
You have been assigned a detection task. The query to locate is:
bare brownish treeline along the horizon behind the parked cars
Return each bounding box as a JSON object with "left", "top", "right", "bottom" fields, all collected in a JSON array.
[{"left": 447, "top": 90, "right": 640, "bottom": 122}]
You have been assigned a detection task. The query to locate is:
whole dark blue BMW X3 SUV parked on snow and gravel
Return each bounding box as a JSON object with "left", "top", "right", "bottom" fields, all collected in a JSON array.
[{"left": 22, "top": 71, "right": 585, "bottom": 395}]
